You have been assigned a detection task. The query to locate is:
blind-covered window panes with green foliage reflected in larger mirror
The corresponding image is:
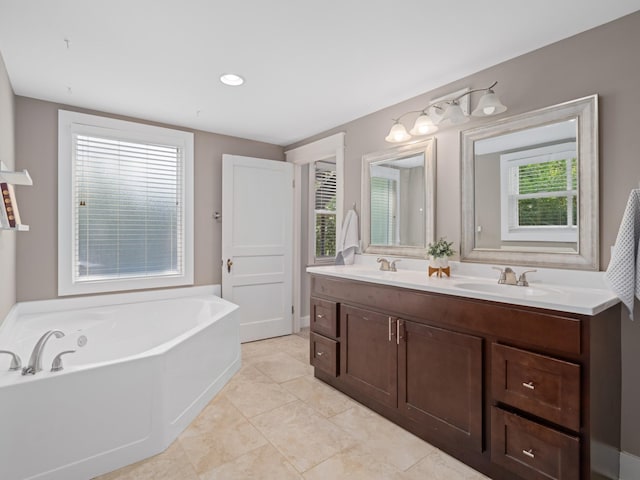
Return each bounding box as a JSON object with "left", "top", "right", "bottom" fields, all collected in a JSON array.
[{"left": 510, "top": 152, "right": 578, "bottom": 227}]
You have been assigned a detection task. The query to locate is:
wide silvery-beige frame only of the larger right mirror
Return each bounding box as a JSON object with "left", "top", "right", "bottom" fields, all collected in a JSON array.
[{"left": 460, "top": 95, "right": 600, "bottom": 270}]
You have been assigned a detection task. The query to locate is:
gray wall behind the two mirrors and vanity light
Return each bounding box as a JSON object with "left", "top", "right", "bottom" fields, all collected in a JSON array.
[{"left": 287, "top": 12, "right": 640, "bottom": 456}]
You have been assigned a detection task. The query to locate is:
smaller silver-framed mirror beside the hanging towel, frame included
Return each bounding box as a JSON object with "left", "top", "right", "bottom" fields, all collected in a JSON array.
[{"left": 361, "top": 138, "right": 436, "bottom": 258}]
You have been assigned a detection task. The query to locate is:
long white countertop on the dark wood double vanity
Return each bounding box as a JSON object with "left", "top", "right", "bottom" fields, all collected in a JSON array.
[{"left": 307, "top": 255, "right": 620, "bottom": 315}]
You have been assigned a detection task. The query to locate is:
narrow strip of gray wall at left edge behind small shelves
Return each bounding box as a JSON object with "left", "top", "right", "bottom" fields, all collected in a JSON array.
[{"left": 0, "top": 55, "right": 15, "bottom": 322}]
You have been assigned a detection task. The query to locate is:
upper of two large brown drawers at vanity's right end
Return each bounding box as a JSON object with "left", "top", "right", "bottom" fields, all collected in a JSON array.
[{"left": 491, "top": 343, "right": 580, "bottom": 431}]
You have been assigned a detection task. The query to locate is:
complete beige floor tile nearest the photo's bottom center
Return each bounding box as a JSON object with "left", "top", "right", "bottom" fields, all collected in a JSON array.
[{"left": 251, "top": 401, "right": 355, "bottom": 472}]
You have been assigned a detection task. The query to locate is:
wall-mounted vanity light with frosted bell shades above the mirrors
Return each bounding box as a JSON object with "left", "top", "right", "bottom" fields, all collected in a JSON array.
[{"left": 385, "top": 82, "right": 507, "bottom": 143}]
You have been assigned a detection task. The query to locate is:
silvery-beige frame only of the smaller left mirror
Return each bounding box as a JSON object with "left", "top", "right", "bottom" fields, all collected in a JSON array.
[{"left": 360, "top": 137, "right": 436, "bottom": 258}]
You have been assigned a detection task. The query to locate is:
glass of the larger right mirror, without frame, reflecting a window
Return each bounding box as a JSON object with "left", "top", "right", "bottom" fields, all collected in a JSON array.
[{"left": 474, "top": 119, "right": 578, "bottom": 252}]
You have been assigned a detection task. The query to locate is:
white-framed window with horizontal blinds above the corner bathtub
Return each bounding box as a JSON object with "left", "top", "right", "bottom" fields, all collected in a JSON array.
[{"left": 59, "top": 111, "right": 193, "bottom": 294}]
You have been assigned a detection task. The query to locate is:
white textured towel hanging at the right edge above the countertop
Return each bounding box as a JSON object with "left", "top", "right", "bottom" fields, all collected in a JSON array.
[{"left": 604, "top": 189, "right": 640, "bottom": 320}]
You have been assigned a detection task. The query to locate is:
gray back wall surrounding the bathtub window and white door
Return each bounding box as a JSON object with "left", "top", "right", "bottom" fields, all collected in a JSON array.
[{"left": 13, "top": 97, "right": 284, "bottom": 300}]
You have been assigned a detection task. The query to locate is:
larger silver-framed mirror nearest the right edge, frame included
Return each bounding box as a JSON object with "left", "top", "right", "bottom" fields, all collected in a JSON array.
[{"left": 461, "top": 95, "right": 599, "bottom": 270}]
